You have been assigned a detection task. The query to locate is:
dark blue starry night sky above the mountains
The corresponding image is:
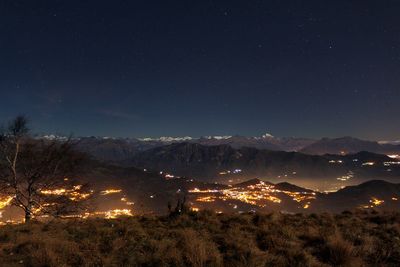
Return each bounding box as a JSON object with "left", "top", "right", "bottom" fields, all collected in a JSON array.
[{"left": 0, "top": 0, "right": 400, "bottom": 140}]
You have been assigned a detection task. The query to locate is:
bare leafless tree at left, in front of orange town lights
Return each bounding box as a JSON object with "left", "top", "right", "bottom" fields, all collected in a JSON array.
[{"left": 0, "top": 116, "right": 90, "bottom": 222}]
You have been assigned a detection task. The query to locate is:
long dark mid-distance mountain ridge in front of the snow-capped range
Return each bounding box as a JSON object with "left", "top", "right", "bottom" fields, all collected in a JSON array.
[{"left": 131, "top": 143, "right": 399, "bottom": 181}]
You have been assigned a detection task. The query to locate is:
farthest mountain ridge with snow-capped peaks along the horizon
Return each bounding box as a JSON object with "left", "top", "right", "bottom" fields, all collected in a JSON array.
[{"left": 38, "top": 134, "right": 400, "bottom": 162}]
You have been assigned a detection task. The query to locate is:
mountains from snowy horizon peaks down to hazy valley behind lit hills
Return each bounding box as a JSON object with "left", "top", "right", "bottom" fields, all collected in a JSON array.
[{"left": 33, "top": 134, "right": 400, "bottom": 194}]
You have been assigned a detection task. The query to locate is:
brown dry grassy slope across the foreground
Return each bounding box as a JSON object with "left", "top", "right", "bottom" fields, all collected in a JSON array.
[{"left": 0, "top": 211, "right": 400, "bottom": 267}]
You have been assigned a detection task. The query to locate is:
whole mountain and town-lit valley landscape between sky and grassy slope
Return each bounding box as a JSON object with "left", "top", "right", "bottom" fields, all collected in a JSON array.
[{"left": 13, "top": 134, "right": 400, "bottom": 219}]
